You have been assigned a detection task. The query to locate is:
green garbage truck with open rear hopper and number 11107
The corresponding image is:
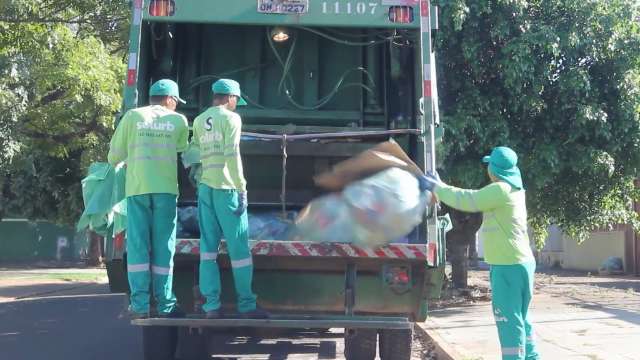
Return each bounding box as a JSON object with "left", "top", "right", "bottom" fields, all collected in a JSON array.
[{"left": 106, "top": 0, "right": 446, "bottom": 360}]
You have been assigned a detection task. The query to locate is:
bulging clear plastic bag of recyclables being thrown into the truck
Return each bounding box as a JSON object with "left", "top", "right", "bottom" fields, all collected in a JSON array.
[{"left": 296, "top": 167, "right": 431, "bottom": 248}]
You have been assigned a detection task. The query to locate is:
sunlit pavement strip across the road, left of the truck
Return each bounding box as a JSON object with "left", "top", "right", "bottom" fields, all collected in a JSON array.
[{"left": 0, "top": 268, "right": 107, "bottom": 303}]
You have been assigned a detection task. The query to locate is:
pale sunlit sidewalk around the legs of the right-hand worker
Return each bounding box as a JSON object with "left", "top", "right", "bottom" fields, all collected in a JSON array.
[{"left": 421, "top": 271, "right": 640, "bottom": 360}]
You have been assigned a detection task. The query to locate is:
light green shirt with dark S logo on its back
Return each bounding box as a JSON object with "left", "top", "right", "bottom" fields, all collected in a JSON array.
[{"left": 191, "top": 106, "right": 247, "bottom": 192}]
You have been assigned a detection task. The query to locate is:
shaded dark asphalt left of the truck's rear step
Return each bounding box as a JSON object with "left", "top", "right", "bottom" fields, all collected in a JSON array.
[{"left": 0, "top": 284, "right": 142, "bottom": 360}]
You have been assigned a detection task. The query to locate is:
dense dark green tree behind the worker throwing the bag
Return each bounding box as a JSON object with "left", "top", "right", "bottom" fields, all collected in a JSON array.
[{"left": 436, "top": 0, "right": 640, "bottom": 286}]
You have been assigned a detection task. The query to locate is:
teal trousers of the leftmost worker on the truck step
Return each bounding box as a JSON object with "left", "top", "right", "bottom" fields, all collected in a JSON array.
[{"left": 127, "top": 194, "right": 176, "bottom": 314}]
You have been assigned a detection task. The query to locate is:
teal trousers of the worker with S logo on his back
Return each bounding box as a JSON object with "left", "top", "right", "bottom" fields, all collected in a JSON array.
[{"left": 198, "top": 184, "right": 256, "bottom": 313}]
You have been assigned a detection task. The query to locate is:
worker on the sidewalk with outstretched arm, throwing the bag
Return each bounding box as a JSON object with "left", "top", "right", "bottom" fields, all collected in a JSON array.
[{"left": 420, "top": 146, "right": 539, "bottom": 360}]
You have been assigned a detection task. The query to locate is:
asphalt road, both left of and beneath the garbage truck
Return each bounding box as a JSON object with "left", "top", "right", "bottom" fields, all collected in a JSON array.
[{"left": 0, "top": 284, "right": 350, "bottom": 360}]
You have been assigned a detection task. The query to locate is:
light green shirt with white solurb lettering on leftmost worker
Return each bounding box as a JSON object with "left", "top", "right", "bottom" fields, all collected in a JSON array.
[{"left": 108, "top": 105, "right": 189, "bottom": 196}]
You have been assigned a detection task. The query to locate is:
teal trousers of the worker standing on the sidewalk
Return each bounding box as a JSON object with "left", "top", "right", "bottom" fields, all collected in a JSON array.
[{"left": 490, "top": 263, "right": 539, "bottom": 360}]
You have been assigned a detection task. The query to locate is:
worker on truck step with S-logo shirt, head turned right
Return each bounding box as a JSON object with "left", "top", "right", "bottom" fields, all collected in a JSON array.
[{"left": 191, "top": 79, "right": 268, "bottom": 319}]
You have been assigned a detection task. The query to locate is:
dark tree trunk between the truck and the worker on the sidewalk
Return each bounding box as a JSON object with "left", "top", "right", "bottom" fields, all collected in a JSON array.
[{"left": 442, "top": 205, "right": 482, "bottom": 289}]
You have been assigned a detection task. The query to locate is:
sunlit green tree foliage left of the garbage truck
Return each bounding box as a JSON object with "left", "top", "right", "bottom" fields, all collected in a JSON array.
[{"left": 0, "top": 0, "right": 127, "bottom": 223}]
